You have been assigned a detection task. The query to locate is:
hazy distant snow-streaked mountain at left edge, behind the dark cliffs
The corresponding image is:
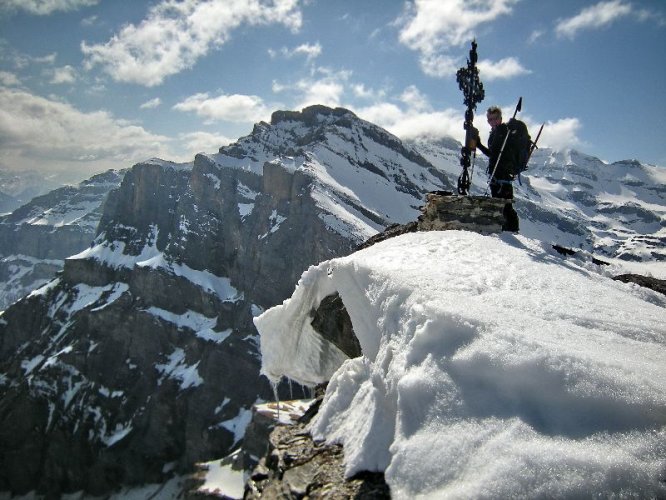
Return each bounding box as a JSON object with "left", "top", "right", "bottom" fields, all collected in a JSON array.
[{"left": 0, "top": 171, "right": 124, "bottom": 310}]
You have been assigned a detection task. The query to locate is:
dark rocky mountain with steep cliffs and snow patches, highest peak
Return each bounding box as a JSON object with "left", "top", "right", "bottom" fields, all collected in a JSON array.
[{"left": 0, "top": 107, "right": 449, "bottom": 494}]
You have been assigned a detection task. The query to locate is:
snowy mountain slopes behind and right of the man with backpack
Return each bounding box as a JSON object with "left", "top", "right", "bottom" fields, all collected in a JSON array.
[{"left": 415, "top": 139, "right": 666, "bottom": 277}]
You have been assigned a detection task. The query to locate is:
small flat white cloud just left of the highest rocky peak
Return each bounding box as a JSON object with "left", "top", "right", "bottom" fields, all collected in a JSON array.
[{"left": 173, "top": 93, "right": 270, "bottom": 122}]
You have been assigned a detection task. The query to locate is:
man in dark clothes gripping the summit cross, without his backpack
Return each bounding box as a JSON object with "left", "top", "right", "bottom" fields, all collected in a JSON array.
[{"left": 476, "top": 106, "right": 519, "bottom": 232}]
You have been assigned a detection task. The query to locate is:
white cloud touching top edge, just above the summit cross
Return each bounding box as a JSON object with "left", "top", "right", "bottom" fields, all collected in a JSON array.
[{"left": 397, "top": 0, "right": 519, "bottom": 76}]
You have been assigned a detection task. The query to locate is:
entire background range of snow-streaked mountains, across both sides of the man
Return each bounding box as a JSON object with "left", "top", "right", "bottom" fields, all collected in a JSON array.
[{"left": 0, "top": 106, "right": 666, "bottom": 495}]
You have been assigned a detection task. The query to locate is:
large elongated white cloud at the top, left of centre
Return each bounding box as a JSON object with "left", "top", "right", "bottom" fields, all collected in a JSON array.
[{"left": 81, "top": 0, "right": 302, "bottom": 86}]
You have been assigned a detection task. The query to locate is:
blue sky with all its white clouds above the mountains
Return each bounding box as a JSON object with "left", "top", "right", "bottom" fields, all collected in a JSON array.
[{"left": 0, "top": 0, "right": 666, "bottom": 180}]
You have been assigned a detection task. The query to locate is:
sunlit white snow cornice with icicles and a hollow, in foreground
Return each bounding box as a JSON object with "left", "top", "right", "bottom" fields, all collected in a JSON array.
[{"left": 255, "top": 231, "right": 666, "bottom": 498}]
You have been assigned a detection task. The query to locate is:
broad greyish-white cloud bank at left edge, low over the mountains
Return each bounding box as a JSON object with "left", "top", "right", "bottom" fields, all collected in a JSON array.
[{"left": 0, "top": 88, "right": 169, "bottom": 174}]
